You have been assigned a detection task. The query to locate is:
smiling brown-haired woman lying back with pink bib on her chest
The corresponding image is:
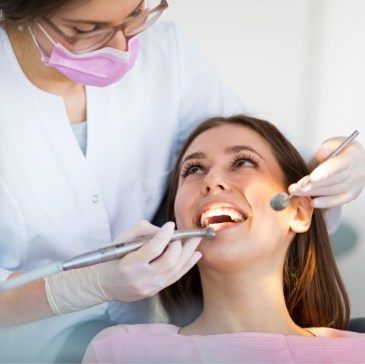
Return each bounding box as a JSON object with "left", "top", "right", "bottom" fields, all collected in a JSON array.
[{"left": 84, "top": 115, "right": 365, "bottom": 362}]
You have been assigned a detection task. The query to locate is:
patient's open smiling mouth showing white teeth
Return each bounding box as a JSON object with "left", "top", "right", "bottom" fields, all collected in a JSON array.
[{"left": 198, "top": 207, "right": 247, "bottom": 230}]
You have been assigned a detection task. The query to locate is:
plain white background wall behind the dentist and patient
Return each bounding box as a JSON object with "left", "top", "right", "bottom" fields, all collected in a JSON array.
[{"left": 163, "top": 0, "right": 365, "bottom": 317}]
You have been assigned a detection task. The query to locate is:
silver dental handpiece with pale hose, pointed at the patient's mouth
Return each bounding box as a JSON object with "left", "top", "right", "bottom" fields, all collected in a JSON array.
[{"left": 0, "top": 228, "right": 216, "bottom": 291}]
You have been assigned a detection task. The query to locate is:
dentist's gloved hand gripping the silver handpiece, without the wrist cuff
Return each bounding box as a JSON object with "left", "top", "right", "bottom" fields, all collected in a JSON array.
[{"left": 98, "top": 221, "right": 201, "bottom": 301}]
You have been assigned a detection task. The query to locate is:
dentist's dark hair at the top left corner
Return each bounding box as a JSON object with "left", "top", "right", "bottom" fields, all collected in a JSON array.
[{"left": 0, "top": 0, "right": 72, "bottom": 24}]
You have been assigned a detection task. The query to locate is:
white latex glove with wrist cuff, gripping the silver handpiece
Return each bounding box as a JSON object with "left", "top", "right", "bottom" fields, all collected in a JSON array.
[{"left": 45, "top": 221, "right": 201, "bottom": 314}]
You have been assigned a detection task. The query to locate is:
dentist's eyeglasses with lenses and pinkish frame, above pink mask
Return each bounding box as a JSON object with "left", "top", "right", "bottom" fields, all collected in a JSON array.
[{"left": 32, "top": 0, "right": 168, "bottom": 54}]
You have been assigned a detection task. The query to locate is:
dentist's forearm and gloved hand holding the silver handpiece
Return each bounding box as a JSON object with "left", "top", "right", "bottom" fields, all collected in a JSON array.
[{"left": 0, "top": 221, "right": 201, "bottom": 326}]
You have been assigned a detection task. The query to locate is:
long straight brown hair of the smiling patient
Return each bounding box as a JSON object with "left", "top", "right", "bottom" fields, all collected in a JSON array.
[{"left": 160, "top": 115, "right": 350, "bottom": 329}]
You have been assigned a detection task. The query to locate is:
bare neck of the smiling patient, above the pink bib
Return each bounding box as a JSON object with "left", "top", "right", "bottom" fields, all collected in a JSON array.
[{"left": 181, "top": 269, "right": 310, "bottom": 336}]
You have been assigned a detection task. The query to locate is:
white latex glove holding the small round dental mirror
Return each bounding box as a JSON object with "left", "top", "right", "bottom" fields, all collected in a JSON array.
[{"left": 289, "top": 137, "right": 365, "bottom": 208}]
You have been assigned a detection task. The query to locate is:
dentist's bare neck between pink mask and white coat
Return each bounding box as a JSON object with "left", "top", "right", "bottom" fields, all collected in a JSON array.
[{"left": 6, "top": 25, "right": 83, "bottom": 96}]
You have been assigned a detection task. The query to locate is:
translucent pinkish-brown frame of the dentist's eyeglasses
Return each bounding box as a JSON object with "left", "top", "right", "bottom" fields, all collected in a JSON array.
[{"left": 31, "top": 0, "right": 168, "bottom": 54}]
